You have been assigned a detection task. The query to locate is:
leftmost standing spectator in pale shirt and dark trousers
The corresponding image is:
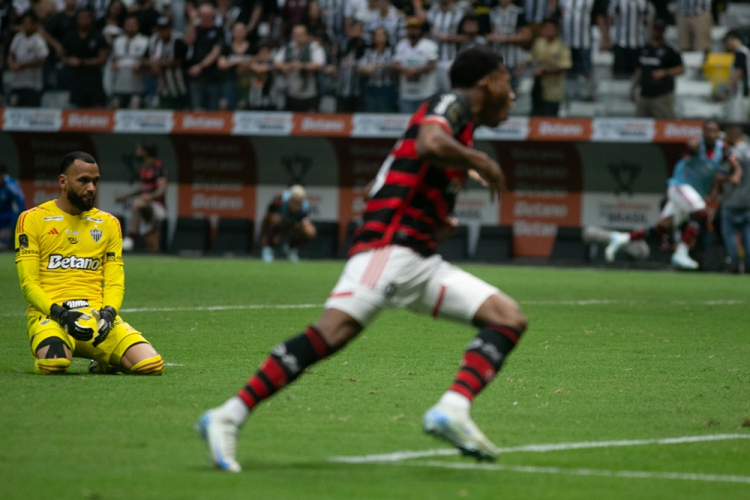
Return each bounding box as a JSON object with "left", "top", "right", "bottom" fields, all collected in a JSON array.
[{"left": 8, "top": 10, "right": 49, "bottom": 108}]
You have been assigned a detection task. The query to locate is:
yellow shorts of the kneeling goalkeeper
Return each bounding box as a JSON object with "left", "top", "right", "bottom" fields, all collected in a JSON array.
[{"left": 26, "top": 309, "right": 150, "bottom": 368}]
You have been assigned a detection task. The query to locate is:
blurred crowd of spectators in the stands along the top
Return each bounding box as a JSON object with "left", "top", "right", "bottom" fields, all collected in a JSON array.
[{"left": 0, "top": 0, "right": 748, "bottom": 120}]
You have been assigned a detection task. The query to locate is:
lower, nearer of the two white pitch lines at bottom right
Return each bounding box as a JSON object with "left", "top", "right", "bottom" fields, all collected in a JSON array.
[{"left": 388, "top": 460, "right": 750, "bottom": 484}]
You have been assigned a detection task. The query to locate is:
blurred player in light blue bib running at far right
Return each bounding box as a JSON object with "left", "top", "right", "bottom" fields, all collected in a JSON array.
[{"left": 604, "top": 120, "right": 742, "bottom": 269}]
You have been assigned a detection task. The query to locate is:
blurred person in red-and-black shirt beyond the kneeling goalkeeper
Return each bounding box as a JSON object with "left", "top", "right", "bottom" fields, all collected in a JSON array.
[{"left": 115, "top": 143, "right": 167, "bottom": 252}]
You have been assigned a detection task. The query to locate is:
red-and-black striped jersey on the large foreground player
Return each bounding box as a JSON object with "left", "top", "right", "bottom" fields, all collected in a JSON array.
[{"left": 349, "top": 92, "right": 474, "bottom": 256}]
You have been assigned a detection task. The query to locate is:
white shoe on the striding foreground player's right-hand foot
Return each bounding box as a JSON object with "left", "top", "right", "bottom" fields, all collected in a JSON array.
[{"left": 422, "top": 403, "right": 500, "bottom": 462}]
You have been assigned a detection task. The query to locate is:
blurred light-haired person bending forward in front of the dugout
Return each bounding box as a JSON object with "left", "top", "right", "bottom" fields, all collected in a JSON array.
[{"left": 260, "top": 185, "right": 317, "bottom": 263}]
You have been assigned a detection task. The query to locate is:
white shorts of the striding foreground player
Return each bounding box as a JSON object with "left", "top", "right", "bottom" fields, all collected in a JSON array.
[{"left": 325, "top": 245, "right": 501, "bottom": 327}]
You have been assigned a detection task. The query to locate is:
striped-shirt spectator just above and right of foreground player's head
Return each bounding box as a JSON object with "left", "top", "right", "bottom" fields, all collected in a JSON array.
[{"left": 486, "top": 0, "right": 534, "bottom": 88}]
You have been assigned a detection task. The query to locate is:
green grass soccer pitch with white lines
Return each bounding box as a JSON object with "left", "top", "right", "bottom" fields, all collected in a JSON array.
[{"left": 0, "top": 255, "right": 750, "bottom": 500}]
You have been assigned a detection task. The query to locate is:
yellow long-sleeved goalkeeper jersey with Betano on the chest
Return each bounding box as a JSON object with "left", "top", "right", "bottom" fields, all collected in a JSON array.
[{"left": 15, "top": 200, "right": 125, "bottom": 314}]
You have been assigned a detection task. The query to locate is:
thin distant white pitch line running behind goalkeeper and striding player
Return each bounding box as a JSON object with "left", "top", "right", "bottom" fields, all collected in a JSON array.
[{"left": 0, "top": 299, "right": 747, "bottom": 318}]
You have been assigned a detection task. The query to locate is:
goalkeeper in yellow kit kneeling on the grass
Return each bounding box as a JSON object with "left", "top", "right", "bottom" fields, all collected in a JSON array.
[{"left": 16, "top": 151, "right": 164, "bottom": 375}]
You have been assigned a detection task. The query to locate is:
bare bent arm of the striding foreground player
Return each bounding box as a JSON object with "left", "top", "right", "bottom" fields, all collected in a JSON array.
[{"left": 416, "top": 123, "right": 505, "bottom": 199}]
